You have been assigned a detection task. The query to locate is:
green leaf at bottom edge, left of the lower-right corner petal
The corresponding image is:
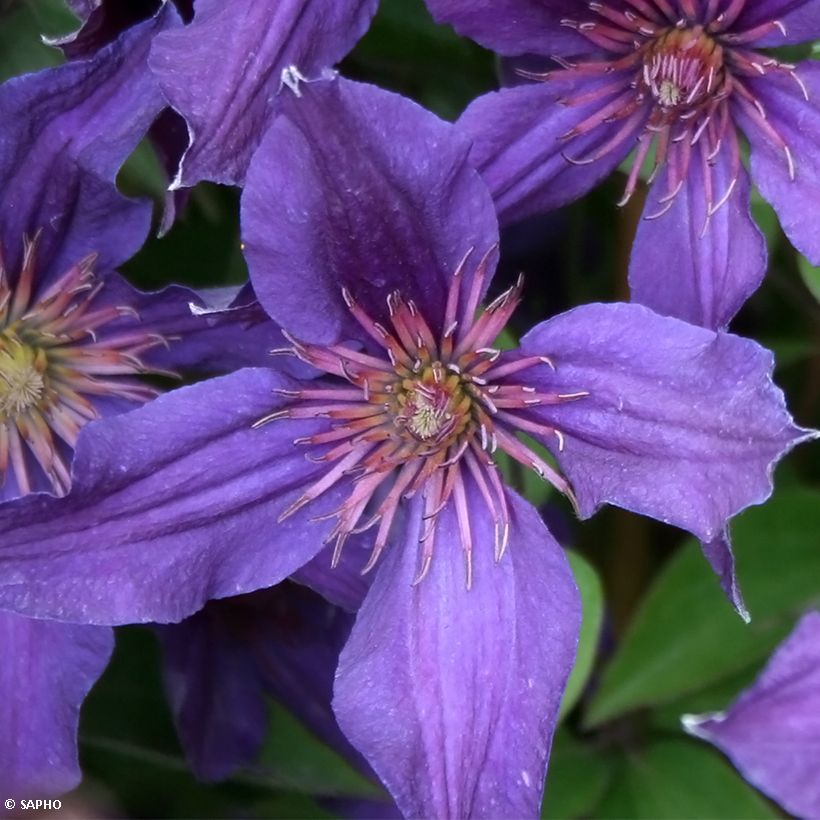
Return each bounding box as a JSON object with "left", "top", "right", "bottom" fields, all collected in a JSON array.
[{"left": 594, "top": 740, "right": 780, "bottom": 820}]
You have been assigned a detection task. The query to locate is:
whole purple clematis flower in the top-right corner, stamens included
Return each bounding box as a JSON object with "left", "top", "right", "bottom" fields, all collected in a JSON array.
[{"left": 428, "top": 0, "right": 820, "bottom": 329}]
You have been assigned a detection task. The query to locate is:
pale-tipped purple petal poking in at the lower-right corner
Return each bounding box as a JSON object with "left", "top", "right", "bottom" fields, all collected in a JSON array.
[{"left": 683, "top": 612, "right": 820, "bottom": 820}]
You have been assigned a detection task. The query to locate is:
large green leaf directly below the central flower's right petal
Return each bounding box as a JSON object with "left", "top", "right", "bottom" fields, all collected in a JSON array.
[{"left": 586, "top": 489, "right": 820, "bottom": 726}]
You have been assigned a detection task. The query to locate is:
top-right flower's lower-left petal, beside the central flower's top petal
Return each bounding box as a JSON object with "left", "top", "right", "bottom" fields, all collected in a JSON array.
[{"left": 456, "top": 73, "right": 648, "bottom": 225}]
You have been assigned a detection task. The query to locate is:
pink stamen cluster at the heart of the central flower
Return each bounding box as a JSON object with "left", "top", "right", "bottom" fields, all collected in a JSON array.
[{"left": 257, "top": 252, "right": 587, "bottom": 587}]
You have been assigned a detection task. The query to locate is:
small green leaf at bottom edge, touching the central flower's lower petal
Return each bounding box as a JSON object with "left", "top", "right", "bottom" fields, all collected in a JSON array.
[{"left": 541, "top": 732, "right": 612, "bottom": 820}]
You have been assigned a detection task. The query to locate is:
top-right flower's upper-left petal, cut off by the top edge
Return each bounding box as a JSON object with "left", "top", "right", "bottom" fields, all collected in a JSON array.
[{"left": 427, "top": 0, "right": 589, "bottom": 57}]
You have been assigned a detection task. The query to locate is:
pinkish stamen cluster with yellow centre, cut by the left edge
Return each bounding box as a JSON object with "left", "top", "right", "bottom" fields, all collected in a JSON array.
[{"left": 0, "top": 237, "right": 165, "bottom": 495}]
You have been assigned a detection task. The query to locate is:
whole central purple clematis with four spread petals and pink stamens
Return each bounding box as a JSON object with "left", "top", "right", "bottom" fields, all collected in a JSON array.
[{"left": 0, "top": 79, "right": 807, "bottom": 816}]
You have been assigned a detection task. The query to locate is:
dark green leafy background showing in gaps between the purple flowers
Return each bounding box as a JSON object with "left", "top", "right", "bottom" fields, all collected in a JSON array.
[{"left": 0, "top": 0, "right": 820, "bottom": 818}]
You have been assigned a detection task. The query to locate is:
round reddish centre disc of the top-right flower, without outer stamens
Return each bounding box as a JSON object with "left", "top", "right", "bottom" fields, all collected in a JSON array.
[{"left": 643, "top": 27, "right": 724, "bottom": 113}]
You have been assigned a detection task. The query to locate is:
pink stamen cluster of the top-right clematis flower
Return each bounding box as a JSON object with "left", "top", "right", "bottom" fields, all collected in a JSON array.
[{"left": 536, "top": 0, "right": 808, "bottom": 233}]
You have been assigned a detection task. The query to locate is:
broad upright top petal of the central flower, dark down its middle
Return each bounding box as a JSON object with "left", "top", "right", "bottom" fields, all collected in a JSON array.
[{"left": 242, "top": 79, "right": 498, "bottom": 342}]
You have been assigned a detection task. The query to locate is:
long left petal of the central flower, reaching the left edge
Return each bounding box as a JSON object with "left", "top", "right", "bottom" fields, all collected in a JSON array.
[{"left": 0, "top": 370, "right": 350, "bottom": 623}]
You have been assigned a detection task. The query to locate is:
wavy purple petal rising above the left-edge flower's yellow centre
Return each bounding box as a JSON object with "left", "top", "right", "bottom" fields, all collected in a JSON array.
[{"left": 0, "top": 6, "right": 177, "bottom": 277}]
